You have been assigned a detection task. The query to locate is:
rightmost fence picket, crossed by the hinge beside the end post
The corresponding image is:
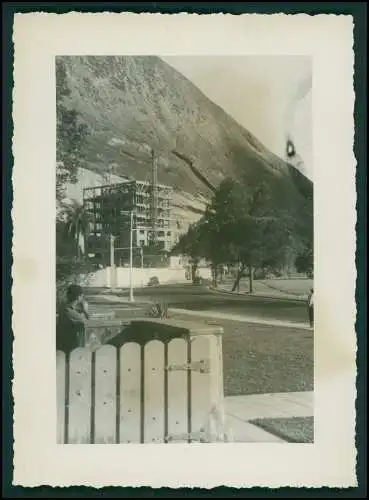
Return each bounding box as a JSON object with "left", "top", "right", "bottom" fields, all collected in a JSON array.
[{"left": 191, "top": 335, "right": 214, "bottom": 440}]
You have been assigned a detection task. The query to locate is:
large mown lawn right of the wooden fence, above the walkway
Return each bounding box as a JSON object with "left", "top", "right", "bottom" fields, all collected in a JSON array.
[{"left": 90, "top": 300, "right": 314, "bottom": 396}]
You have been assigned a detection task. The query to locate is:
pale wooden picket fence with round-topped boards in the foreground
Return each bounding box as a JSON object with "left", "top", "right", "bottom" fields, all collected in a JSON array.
[{"left": 57, "top": 320, "right": 226, "bottom": 444}]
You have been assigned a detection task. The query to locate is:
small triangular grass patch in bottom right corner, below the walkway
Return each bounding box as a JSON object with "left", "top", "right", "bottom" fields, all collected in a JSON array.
[{"left": 250, "top": 417, "right": 314, "bottom": 443}]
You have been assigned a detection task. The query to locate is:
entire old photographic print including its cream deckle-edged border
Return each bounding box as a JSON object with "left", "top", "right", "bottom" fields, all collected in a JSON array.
[{"left": 12, "top": 12, "right": 357, "bottom": 488}]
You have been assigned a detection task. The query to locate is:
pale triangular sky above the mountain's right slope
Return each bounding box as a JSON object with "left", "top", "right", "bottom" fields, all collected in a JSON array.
[{"left": 162, "top": 56, "right": 313, "bottom": 179}]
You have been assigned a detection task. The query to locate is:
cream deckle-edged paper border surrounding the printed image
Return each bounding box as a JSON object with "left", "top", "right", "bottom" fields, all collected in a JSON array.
[{"left": 12, "top": 13, "right": 356, "bottom": 488}]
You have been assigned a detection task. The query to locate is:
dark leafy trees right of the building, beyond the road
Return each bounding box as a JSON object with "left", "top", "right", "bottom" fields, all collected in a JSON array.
[{"left": 174, "top": 179, "right": 312, "bottom": 293}]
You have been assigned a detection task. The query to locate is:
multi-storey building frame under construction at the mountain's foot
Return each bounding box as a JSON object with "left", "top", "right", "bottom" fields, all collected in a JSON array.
[{"left": 83, "top": 180, "right": 176, "bottom": 261}]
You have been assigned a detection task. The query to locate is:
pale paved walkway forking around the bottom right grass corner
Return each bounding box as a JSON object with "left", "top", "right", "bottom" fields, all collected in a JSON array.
[{"left": 225, "top": 392, "right": 314, "bottom": 443}]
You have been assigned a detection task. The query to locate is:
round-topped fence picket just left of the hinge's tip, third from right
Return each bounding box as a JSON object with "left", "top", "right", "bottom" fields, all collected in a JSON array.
[{"left": 144, "top": 340, "right": 165, "bottom": 443}]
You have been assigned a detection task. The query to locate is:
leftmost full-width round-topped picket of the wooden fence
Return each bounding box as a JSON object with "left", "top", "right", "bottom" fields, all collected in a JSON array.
[{"left": 68, "top": 348, "right": 92, "bottom": 444}]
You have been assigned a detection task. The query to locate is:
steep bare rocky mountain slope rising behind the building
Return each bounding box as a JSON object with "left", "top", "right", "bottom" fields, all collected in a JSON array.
[{"left": 57, "top": 56, "right": 312, "bottom": 231}]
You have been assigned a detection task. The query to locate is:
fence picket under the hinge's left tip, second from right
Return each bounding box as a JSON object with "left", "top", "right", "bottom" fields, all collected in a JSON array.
[{"left": 168, "top": 338, "right": 188, "bottom": 443}]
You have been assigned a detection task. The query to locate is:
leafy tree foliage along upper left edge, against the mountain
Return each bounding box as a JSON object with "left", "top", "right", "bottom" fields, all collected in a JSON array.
[{"left": 56, "top": 57, "right": 88, "bottom": 202}]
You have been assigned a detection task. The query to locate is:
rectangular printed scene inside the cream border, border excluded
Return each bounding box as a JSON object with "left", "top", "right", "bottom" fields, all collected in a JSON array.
[{"left": 55, "top": 56, "right": 314, "bottom": 444}]
